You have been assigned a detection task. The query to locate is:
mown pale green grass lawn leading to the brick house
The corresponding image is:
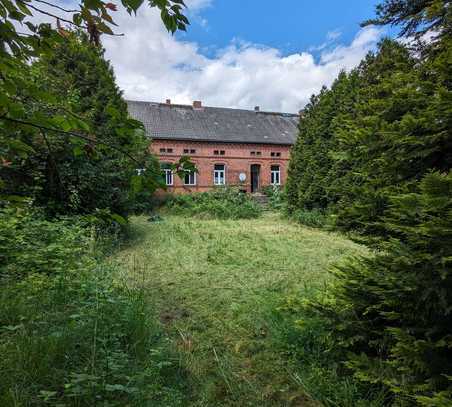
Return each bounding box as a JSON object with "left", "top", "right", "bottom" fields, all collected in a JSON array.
[{"left": 112, "top": 213, "right": 365, "bottom": 407}]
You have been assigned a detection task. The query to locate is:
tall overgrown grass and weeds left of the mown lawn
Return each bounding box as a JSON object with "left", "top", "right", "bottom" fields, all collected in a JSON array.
[{"left": 0, "top": 211, "right": 188, "bottom": 406}]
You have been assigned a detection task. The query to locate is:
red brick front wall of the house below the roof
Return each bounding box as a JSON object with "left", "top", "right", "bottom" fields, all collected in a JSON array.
[{"left": 150, "top": 139, "right": 291, "bottom": 193}]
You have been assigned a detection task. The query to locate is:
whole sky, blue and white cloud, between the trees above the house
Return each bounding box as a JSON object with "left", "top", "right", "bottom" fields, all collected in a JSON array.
[{"left": 36, "top": 0, "right": 385, "bottom": 112}]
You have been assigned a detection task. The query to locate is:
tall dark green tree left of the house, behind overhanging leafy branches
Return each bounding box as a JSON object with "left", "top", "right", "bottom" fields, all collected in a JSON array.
[{"left": 0, "top": 32, "right": 159, "bottom": 216}]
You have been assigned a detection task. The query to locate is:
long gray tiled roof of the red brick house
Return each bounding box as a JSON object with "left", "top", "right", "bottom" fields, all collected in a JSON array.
[{"left": 127, "top": 101, "right": 299, "bottom": 145}]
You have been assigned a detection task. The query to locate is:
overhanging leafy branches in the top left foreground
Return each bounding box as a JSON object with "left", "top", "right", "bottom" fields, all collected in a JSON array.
[{"left": 0, "top": 0, "right": 188, "bottom": 161}]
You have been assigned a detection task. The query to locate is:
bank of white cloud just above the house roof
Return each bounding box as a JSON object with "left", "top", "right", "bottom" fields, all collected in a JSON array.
[{"left": 103, "top": 7, "right": 382, "bottom": 112}]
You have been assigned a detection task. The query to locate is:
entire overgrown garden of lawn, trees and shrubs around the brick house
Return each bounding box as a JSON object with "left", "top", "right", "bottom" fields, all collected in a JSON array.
[{"left": 0, "top": 0, "right": 452, "bottom": 407}]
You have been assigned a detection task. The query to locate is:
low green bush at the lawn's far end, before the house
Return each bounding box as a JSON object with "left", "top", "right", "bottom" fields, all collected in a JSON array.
[{"left": 167, "top": 187, "right": 262, "bottom": 219}]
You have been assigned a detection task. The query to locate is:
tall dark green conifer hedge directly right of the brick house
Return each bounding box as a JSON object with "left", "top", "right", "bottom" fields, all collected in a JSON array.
[{"left": 287, "top": 40, "right": 452, "bottom": 235}]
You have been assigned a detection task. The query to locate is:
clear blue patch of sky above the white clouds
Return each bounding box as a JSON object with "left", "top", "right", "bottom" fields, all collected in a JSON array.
[{"left": 178, "top": 0, "right": 384, "bottom": 55}]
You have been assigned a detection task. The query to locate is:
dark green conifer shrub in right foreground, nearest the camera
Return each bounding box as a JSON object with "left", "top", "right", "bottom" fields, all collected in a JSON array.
[{"left": 312, "top": 173, "right": 452, "bottom": 406}]
